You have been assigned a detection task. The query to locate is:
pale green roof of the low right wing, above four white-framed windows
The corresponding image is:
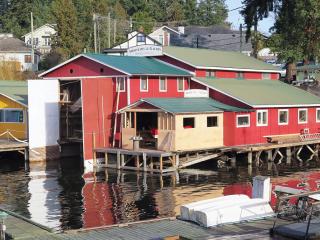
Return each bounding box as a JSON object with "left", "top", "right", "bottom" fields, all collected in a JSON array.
[{"left": 194, "top": 78, "right": 320, "bottom": 106}]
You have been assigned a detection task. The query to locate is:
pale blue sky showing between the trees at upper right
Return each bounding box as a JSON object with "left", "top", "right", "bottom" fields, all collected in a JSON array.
[{"left": 226, "top": 0, "right": 274, "bottom": 35}]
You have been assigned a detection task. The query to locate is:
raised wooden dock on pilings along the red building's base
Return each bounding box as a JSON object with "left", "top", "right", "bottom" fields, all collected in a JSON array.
[{"left": 93, "top": 135, "right": 320, "bottom": 173}]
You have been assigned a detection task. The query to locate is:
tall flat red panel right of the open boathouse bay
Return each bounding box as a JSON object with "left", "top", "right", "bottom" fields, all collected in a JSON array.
[{"left": 81, "top": 78, "right": 114, "bottom": 160}]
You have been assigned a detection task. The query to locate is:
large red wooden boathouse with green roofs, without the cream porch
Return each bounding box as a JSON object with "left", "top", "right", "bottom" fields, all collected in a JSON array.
[{"left": 34, "top": 47, "right": 320, "bottom": 168}]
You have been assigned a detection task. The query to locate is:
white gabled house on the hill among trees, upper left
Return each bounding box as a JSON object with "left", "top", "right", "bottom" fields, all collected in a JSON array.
[{"left": 23, "top": 24, "right": 57, "bottom": 54}]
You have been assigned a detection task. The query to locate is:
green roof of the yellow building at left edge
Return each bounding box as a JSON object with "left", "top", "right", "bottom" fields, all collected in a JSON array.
[{"left": 0, "top": 80, "right": 28, "bottom": 106}]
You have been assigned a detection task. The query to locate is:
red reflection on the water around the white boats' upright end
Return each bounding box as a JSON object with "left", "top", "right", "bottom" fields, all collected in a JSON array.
[{"left": 223, "top": 172, "right": 320, "bottom": 206}]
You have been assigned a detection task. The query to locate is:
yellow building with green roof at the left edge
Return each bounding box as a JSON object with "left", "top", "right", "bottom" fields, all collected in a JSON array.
[{"left": 0, "top": 80, "right": 28, "bottom": 140}]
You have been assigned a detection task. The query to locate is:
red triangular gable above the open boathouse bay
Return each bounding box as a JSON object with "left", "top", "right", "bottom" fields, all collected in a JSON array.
[{"left": 43, "top": 57, "right": 124, "bottom": 78}]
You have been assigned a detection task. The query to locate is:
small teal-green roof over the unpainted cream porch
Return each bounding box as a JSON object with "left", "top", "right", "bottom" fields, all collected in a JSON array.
[{"left": 141, "top": 98, "right": 248, "bottom": 113}]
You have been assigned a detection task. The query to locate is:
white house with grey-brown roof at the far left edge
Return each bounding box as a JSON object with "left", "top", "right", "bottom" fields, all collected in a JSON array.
[{"left": 0, "top": 34, "right": 40, "bottom": 71}]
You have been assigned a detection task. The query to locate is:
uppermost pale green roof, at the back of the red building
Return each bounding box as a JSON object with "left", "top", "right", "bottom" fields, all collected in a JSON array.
[{"left": 163, "top": 47, "right": 280, "bottom": 72}]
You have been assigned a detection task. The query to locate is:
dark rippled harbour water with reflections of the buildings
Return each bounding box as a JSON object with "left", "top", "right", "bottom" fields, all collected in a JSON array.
[{"left": 0, "top": 156, "right": 320, "bottom": 230}]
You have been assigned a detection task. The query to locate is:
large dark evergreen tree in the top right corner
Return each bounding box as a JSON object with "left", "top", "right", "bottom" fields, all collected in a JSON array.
[{"left": 242, "top": 0, "right": 320, "bottom": 80}]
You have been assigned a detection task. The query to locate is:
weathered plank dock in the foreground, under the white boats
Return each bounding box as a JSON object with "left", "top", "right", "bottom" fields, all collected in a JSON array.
[{"left": 1, "top": 205, "right": 279, "bottom": 240}]
